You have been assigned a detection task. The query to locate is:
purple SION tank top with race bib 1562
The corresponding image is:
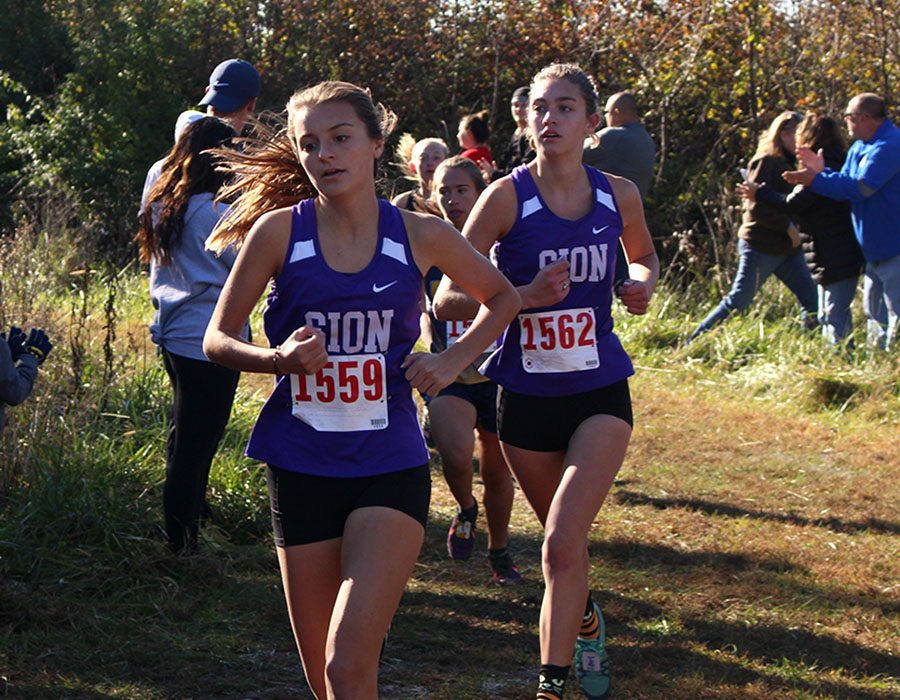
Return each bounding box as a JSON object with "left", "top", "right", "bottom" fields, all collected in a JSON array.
[{"left": 481, "top": 165, "right": 634, "bottom": 396}]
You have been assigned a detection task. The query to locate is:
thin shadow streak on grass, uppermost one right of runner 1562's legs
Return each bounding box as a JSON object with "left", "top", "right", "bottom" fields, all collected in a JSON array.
[{"left": 613, "top": 491, "right": 900, "bottom": 535}]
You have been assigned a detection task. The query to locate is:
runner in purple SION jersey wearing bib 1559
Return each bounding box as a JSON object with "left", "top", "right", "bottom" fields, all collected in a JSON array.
[{"left": 204, "top": 81, "right": 520, "bottom": 700}]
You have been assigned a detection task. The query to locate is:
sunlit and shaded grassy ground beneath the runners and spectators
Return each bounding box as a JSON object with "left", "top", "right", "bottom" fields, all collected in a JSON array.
[{"left": 0, "top": 227, "right": 900, "bottom": 700}]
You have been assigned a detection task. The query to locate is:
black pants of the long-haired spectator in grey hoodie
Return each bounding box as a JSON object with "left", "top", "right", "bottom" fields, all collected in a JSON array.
[{"left": 162, "top": 348, "right": 240, "bottom": 551}]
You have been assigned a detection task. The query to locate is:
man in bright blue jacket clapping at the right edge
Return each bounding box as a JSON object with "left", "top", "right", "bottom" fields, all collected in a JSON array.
[{"left": 784, "top": 92, "right": 900, "bottom": 348}]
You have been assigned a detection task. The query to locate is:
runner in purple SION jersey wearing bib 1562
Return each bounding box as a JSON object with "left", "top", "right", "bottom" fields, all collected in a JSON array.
[{"left": 435, "top": 64, "right": 659, "bottom": 700}]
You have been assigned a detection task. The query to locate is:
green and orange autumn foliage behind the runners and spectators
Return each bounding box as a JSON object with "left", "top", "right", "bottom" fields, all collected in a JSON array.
[{"left": 0, "top": 0, "right": 900, "bottom": 278}]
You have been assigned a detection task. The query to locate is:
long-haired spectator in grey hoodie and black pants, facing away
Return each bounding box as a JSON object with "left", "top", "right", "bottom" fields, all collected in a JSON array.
[{"left": 136, "top": 117, "right": 248, "bottom": 552}]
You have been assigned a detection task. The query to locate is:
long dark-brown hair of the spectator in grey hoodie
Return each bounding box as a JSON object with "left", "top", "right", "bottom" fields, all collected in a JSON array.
[{"left": 135, "top": 117, "right": 236, "bottom": 265}]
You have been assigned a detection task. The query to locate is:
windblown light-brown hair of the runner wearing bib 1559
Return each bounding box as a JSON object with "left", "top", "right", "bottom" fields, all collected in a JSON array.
[{"left": 207, "top": 80, "right": 397, "bottom": 250}]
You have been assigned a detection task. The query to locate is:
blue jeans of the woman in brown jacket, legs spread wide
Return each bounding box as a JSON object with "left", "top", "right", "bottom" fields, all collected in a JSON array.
[{"left": 690, "top": 239, "right": 820, "bottom": 340}]
